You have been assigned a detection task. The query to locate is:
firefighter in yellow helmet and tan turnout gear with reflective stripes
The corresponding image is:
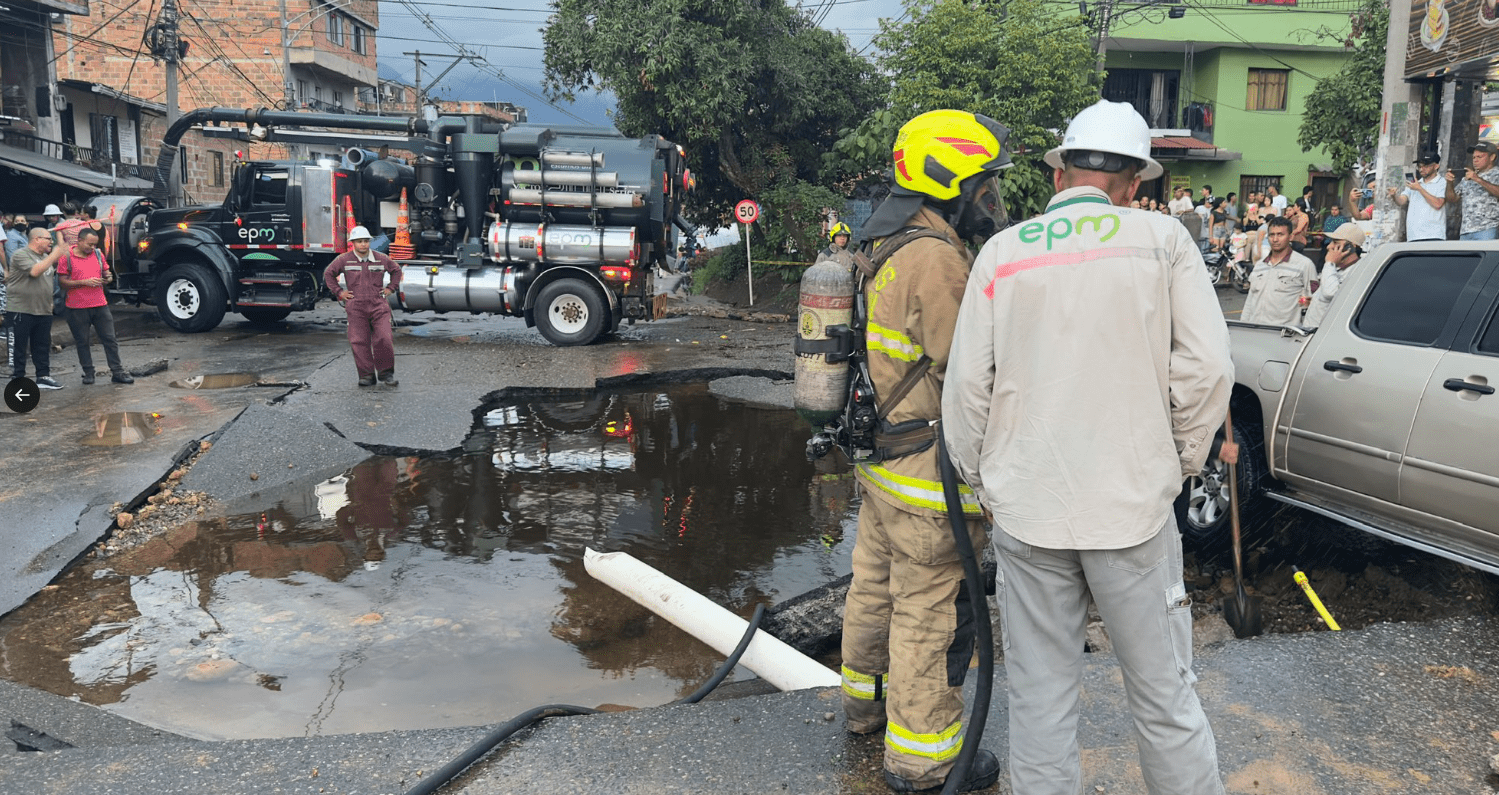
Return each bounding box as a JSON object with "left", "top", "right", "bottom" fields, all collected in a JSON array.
[{"left": 842, "top": 110, "right": 1010, "bottom": 792}]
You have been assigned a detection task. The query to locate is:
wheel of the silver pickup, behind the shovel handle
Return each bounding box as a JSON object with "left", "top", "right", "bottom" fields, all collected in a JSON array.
[{"left": 1172, "top": 405, "right": 1265, "bottom": 545}]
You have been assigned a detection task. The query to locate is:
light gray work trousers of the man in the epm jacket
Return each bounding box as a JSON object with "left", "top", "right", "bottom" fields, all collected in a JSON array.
[{"left": 994, "top": 518, "right": 1223, "bottom": 795}]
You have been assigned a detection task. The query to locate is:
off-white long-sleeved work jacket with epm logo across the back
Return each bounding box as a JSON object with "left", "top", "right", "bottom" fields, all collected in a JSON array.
[{"left": 943, "top": 188, "right": 1234, "bottom": 549}]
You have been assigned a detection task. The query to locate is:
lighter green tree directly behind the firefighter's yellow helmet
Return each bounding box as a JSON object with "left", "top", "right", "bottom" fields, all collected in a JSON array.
[{"left": 826, "top": 0, "right": 1099, "bottom": 216}]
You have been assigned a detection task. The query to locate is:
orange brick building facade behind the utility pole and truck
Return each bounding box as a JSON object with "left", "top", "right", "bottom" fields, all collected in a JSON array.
[{"left": 55, "top": 0, "right": 379, "bottom": 201}]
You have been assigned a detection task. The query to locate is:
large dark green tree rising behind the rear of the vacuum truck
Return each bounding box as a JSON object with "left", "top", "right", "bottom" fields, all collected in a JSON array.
[{"left": 543, "top": 0, "right": 881, "bottom": 224}]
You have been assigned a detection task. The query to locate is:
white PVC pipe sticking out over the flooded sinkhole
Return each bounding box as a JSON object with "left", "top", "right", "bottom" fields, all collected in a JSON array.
[{"left": 583, "top": 549, "right": 842, "bottom": 690}]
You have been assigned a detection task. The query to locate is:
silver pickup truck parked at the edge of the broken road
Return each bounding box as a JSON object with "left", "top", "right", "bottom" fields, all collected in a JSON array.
[{"left": 1177, "top": 242, "right": 1499, "bottom": 573}]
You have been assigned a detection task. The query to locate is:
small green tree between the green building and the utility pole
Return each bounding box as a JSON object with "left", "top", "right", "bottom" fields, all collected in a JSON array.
[{"left": 1297, "top": 0, "right": 1390, "bottom": 173}]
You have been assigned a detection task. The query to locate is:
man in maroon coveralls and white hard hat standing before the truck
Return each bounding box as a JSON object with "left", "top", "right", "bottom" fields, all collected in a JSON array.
[{"left": 322, "top": 227, "right": 400, "bottom": 387}]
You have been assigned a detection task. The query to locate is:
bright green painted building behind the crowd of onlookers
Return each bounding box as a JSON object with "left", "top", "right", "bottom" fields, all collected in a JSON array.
[{"left": 1103, "top": 0, "right": 1358, "bottom": 209}]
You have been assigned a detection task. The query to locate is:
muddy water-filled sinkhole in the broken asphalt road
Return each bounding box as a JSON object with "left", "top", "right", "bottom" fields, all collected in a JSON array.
[{"left": 0, "top": 386, "right": 856, "bottom": 738}]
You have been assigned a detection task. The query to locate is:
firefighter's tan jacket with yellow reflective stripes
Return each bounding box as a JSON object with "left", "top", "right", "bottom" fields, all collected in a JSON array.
[{"left": 856, "top": 207, "right": 979, "bottom": 516}]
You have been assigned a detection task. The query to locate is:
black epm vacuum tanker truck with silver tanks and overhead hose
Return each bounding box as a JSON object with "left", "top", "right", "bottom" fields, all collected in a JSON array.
[{"left": 93, "top": 108, "right": 694, "bottom": 345}]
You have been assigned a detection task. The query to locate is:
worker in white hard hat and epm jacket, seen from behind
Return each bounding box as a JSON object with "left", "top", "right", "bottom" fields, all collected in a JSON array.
[{"left": 941, "top": 101, "right": 1237, "bottom": 795}]
